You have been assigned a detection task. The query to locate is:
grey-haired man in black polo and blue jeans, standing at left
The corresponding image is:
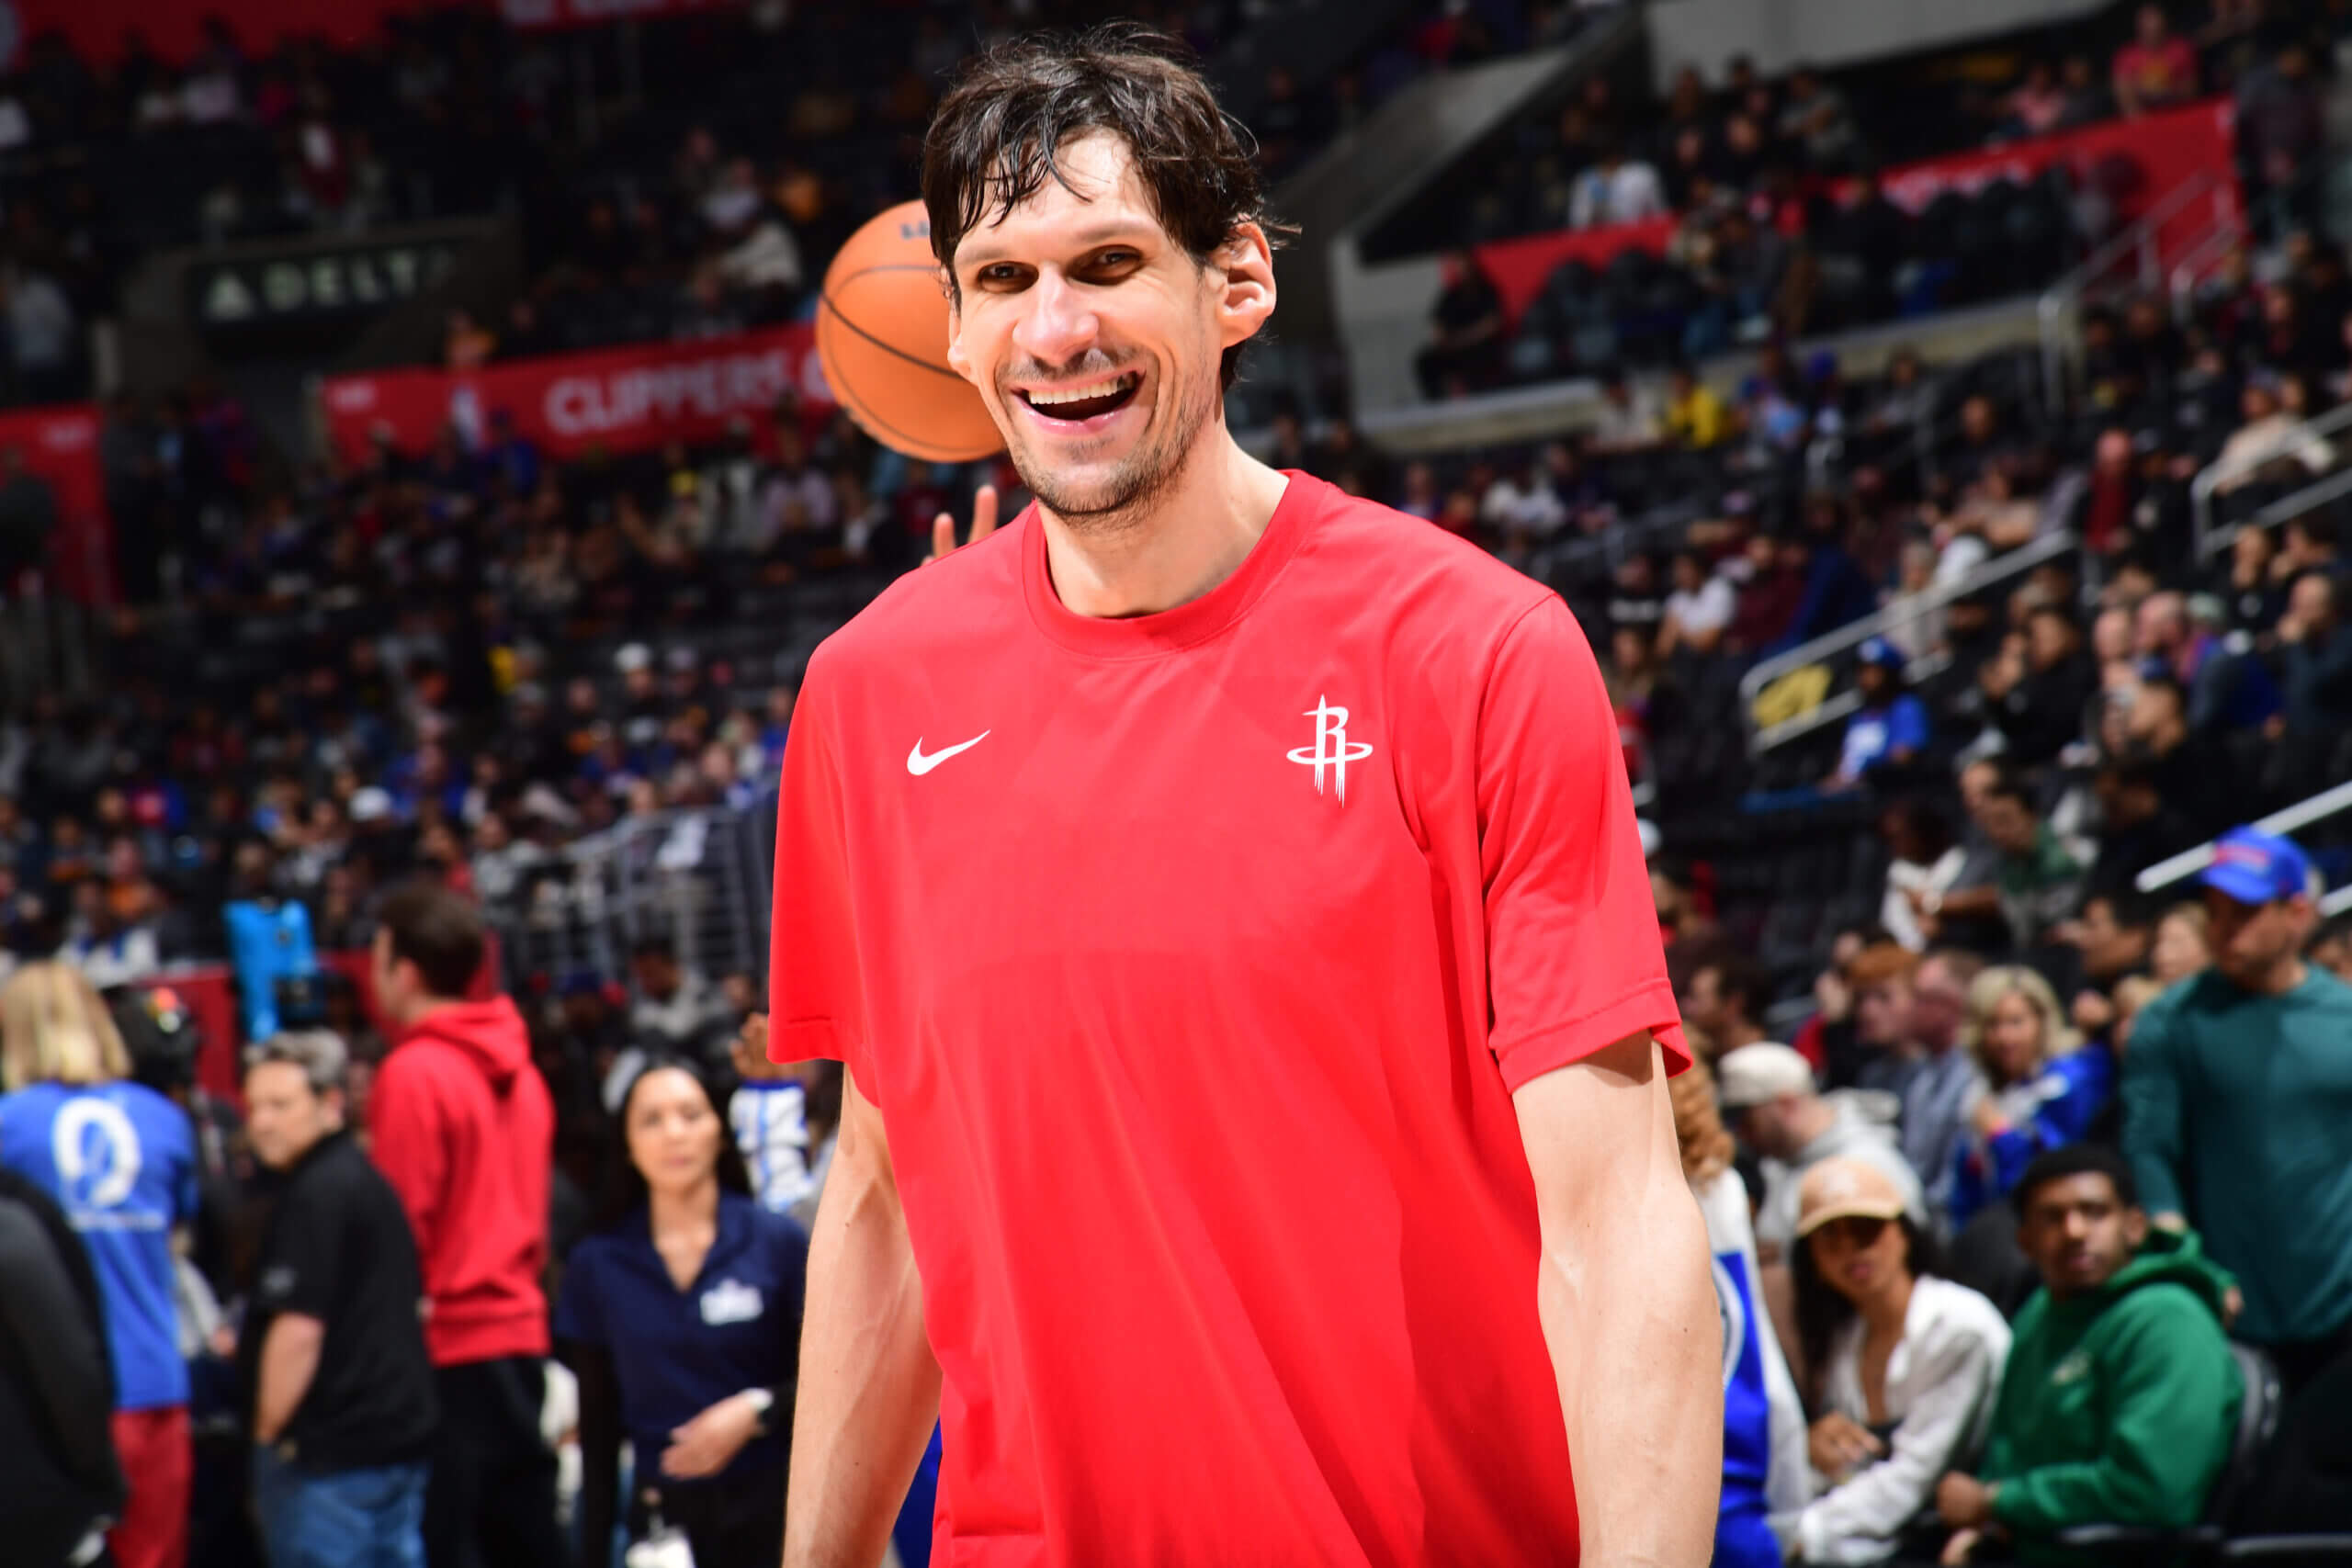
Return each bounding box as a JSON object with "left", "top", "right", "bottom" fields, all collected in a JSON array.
[{"left": 238, "top": 1032, "right": 437, "bottom": 1568}]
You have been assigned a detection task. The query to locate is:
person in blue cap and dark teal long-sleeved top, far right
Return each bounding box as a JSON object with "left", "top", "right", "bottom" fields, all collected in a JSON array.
[{"left": 2124, "top": 828, "right": 2352, "bottom": 1394}]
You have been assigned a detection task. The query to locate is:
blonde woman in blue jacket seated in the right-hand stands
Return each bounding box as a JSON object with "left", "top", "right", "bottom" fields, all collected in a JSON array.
[{"left": 1950, "top": 968, "right": 2114, "bottom": 1229}]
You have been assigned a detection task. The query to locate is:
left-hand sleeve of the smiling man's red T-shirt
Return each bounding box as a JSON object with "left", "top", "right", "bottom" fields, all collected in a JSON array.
[{"left": 767, "top": 665, "right": 882, "bottom": 1105}]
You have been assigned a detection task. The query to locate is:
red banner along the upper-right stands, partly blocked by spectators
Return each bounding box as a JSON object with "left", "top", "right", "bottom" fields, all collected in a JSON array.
[{"left": 1477, "top": 98, "right": 2237, "bottom": 320}]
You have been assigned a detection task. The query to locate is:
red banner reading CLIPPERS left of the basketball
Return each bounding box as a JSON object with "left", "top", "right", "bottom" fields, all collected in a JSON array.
[{"left": 320, "top": 322, "right": 832, "bottom": 461}]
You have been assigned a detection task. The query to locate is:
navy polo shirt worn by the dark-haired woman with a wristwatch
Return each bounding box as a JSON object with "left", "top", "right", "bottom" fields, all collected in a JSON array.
[{"left": 555, "top": 1192, "right": 809, "bottom": 1485}]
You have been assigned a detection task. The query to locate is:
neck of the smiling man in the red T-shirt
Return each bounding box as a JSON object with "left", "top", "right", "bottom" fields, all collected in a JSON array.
[{"left": 1040, "top": 434, "right": 1289, "bottom": 621}]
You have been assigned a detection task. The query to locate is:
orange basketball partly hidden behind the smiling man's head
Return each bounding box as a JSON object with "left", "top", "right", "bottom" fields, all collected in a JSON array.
[{"left": 816, "top": 202, "right": 1004, "bottom": 463}]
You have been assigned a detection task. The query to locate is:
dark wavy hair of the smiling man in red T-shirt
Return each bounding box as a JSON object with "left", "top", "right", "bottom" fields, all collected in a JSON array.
[{"left": 922, "top": 21, "right": 1289, "bottom": 386}]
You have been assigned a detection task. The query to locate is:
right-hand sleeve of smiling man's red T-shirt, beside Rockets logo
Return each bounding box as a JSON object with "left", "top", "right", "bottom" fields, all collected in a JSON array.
[{"left": 1477, "top": 594, "right": 1691, "bottom": 1090}]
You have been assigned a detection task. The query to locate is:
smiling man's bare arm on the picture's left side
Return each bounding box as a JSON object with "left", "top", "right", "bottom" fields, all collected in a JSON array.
[{"left": 783, "top": 1075, "right": 938, "bottom": 1568}]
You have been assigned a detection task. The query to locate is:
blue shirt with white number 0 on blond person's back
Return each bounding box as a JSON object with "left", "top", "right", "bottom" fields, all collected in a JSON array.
[{"left": 0, "top": 1084, "right": 195, "bottom": 1411}]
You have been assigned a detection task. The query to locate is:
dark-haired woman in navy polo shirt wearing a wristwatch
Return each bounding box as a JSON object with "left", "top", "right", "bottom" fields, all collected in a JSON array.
[{"left": 555, "top": 1060, "right": 809, "bottom": 1568}]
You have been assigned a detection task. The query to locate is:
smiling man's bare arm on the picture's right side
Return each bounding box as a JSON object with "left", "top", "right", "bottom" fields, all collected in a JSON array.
[{"left": 1515, "top": 1034, "right": 1724, "bottom": 1568}]
